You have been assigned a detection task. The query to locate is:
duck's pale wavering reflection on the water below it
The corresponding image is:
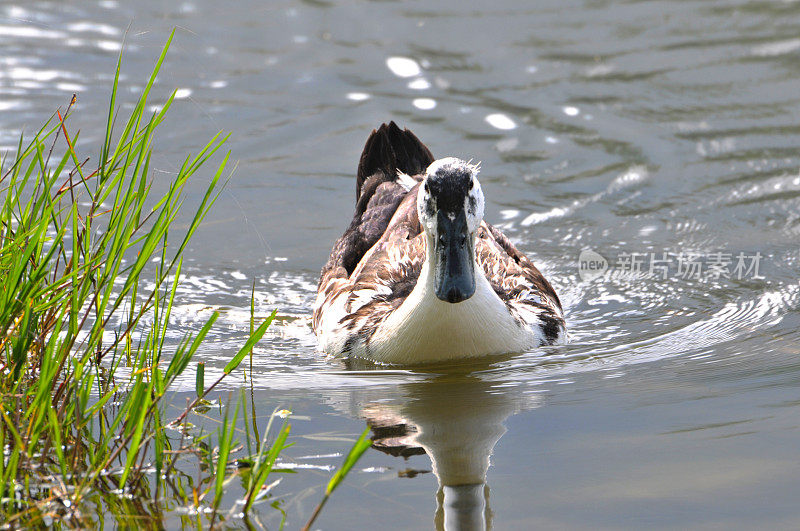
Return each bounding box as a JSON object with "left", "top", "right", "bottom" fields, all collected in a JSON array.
[{"left": 350, "top": 374, "right": 538, "bottom": 530}]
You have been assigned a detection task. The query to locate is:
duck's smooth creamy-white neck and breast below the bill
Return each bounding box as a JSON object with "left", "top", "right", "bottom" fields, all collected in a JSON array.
[{"left": 370, "top": 233, "right": 530, "bottom": 364}]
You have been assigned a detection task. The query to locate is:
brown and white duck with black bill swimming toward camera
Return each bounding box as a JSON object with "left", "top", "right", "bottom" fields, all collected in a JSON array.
[{"left": 312, "top": 121, "right": 567, "bottom": 365}]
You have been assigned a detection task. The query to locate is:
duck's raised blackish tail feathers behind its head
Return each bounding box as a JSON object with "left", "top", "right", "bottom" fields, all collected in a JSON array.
[{"left": 356, "top": 122, "right": 433, "bottom": 202}]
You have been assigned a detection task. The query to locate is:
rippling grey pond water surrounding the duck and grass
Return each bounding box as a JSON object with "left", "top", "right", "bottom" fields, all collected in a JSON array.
[{"left": 0, "top": 0, "right": 800, "bottom": 529}]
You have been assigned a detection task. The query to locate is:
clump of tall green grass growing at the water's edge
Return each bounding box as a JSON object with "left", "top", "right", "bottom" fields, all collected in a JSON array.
[{"left": 0, "top": 31, "right": 371, "bottom": 529}]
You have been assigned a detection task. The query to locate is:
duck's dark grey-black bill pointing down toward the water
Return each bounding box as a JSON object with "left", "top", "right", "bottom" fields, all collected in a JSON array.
[{"left": 434, "top": 210, "right": 475, "bottom": 303}]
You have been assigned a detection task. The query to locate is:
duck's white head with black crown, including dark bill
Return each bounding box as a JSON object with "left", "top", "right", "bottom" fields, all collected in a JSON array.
[{"left": 417, "top": 157, "right": 484, "bottom": 303}]
